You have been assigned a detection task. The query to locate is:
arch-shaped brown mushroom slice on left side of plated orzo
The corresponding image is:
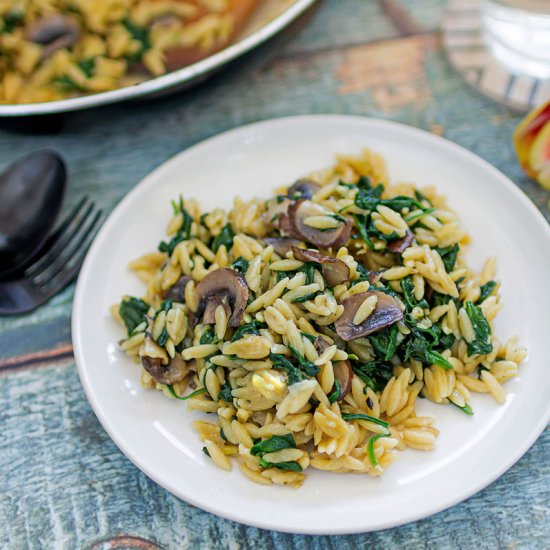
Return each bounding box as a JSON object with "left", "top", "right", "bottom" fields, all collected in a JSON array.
[{"left": 195, "top": 267, "right": 248, "bottom": 327}]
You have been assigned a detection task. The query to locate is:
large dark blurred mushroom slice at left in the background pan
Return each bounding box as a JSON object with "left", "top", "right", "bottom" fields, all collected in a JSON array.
[{"left": 25, "top": 15, "right": 80, "bottom": 59}]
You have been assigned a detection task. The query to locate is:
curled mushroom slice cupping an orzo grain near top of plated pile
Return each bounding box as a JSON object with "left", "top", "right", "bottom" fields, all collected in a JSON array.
[{"left": 288, "top": 200, "right": 352, "bottom": 248}]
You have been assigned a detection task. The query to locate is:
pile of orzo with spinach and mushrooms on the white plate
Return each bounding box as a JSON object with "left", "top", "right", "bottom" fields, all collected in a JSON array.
[{"left": 113, "top": 151, "right": 526, "bottom": 487}]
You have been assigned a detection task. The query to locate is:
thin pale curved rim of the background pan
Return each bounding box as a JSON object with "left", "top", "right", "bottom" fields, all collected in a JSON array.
[{"left": 0, "top": 0, "right": 317, "bottom": 118}]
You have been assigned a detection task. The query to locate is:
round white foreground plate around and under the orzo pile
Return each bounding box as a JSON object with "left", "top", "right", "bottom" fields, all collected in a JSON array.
[{"left": 72, "top": 116, "right": 550, "bottom": 534}]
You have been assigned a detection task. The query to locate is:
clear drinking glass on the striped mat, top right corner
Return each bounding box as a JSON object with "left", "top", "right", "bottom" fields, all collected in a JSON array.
[{"left": 481, "top": 0, "right": 550, "bottom": 79}]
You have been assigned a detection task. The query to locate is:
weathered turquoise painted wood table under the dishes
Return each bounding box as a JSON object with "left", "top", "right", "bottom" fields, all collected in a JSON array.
[{"left": 0, "top": 0, "right": 550, "bottom": 549}]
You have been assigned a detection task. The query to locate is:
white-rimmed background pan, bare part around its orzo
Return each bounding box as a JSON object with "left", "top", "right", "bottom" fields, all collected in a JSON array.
[{"left": 0, "top": 0, "right": 316, "bottom": 117}]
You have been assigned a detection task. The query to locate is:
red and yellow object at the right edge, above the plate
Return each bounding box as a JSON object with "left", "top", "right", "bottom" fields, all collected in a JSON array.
[{"left": 514, "top": 101, "right": 550, "bottom": 189}]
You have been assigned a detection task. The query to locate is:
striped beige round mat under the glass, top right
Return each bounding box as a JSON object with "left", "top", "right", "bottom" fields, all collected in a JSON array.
[{"left": 443, "top": 0, "right": 550, "bottom": 111}]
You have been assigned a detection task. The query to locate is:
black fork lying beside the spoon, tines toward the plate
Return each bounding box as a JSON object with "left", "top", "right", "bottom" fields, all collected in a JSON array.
[{"left": 0, "top": 197, "right": 102, "bottom": 315}]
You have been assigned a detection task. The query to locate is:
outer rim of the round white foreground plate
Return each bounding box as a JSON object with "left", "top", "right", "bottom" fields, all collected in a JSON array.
[{"left": 71, "top": 114, "right": 550, "bottom": 535}]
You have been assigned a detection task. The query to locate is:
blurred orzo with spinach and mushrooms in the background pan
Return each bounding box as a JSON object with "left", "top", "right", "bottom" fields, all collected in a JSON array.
[{"left": 0, "top": 0, "right": 260, "bottom": 104}]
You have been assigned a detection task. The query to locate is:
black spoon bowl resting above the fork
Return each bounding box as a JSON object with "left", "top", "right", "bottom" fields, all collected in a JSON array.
[{"left": 0, "top": 149, "right": 67, "bottom": 278}]
